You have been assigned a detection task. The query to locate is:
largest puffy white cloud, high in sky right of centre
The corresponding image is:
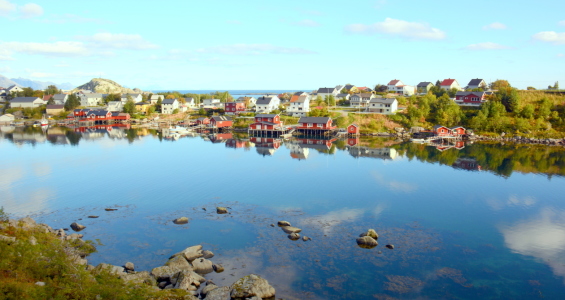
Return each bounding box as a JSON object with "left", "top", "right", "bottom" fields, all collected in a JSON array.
[{"left": 345, "top": 18, "right": 446, "bottom": 40}]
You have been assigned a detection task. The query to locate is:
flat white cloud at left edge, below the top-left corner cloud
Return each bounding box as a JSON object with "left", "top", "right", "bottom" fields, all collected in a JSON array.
[{"left": 0, "top": 42, "right": 88, "bottom": 56}]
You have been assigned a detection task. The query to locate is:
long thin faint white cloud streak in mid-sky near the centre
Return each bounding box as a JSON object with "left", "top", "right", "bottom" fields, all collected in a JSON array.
[{"left": 197, "top": 44, "right": 316, "bottom": 55}]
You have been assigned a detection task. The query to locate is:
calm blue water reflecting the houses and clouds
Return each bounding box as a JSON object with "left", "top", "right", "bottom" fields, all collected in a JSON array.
[{"left": 0, "top": 127, "right": 565, "bottom": 299}]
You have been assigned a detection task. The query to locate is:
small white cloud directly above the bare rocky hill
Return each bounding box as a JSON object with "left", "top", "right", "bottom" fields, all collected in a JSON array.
[{"left": 77, "top": 32, "right": 159, "bottom": 50}]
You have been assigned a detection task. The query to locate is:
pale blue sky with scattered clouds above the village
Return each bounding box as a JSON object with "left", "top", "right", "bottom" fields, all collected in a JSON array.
[{"left": 0, "top": 0, "right": 565, "bottom": 90}]
